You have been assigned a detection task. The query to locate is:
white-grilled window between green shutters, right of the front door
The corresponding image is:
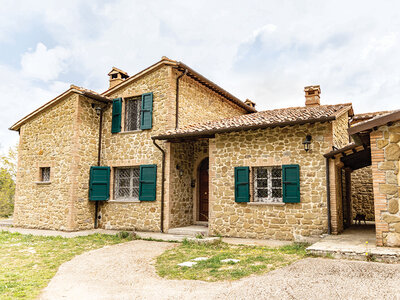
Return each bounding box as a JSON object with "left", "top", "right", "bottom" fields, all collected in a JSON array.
[{"left": 253, "top": 167, "right": 283, "bottom": 203}]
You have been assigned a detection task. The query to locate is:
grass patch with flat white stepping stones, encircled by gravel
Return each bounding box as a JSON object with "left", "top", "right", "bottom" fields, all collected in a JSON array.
[{"left": 156, "top": 242, "right": 307, "bottom": 281}]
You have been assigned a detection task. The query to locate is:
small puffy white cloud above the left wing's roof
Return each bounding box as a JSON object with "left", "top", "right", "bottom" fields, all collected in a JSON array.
[{"left": 21, "top": 43, "right": 71, "bottom": 81}]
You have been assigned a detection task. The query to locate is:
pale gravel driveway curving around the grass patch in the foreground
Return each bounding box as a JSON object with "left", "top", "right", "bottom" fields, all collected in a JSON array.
[{"left": 41, "top": 240, "right": 400, "bottom": 300}]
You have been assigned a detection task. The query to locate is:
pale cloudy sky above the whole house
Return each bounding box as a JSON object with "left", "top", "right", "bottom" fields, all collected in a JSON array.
[{"left": 0, "top": 0, "right": 400, "bottom": 151}]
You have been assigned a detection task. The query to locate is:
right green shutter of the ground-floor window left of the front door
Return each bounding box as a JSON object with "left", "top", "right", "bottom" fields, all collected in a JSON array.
[{"left": 139, "top": 165, "right": 157, "bottom": 201}]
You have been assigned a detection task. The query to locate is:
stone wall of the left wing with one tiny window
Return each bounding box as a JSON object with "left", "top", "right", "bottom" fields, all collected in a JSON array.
[{"left": 14, "top": 94, "right": 78, "bottom": 230}]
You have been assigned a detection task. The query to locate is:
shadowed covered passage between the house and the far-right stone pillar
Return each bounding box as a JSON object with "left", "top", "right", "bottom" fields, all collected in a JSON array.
[{"left": 325, "top": 141, "right": 375, "bottom": 234}]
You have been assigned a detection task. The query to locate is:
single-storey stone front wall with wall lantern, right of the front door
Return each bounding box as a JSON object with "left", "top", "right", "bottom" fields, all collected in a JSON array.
[{"left": 209, "top": 123, "right": 332, "bottom": 240}]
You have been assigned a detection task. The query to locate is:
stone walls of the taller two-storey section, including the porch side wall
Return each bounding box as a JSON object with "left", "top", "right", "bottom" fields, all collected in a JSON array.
[{"left": 99, "top": 66, "right": 245, "bottom": 231}]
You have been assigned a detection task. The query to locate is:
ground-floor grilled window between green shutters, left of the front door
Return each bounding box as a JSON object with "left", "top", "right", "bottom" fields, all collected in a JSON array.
[{"left": 114, "top": 167, "right": 140, "bottom": 201}]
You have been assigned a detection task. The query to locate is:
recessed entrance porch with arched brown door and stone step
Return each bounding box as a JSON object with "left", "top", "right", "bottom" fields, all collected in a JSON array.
[{"left": 164, "top": 138, "right": 210, "bottom": 235}]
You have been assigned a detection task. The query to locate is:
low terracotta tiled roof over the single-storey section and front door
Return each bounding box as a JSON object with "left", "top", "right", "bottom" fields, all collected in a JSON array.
[{"left": 153, "top": 103, "right": 352, "bottom": 139}]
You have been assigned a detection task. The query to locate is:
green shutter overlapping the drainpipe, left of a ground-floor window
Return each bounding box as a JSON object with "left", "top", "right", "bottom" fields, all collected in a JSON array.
[{"left": 89, "top": 167, "right": 110, "bottom": 201}]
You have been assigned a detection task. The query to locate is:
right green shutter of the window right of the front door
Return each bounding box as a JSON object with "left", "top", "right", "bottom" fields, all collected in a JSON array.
[{"left": 282, "top": 165, "right": 300, "bottom": 203}]
